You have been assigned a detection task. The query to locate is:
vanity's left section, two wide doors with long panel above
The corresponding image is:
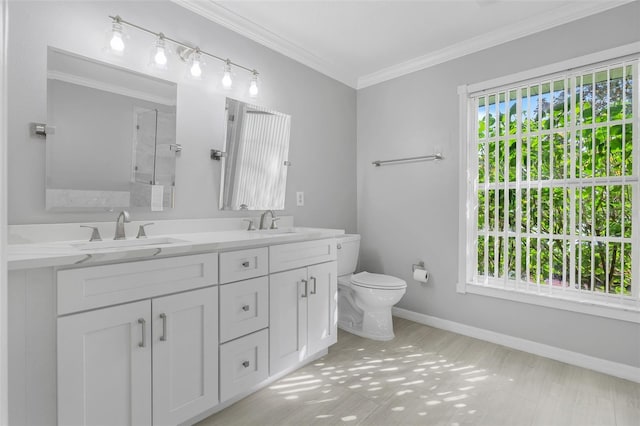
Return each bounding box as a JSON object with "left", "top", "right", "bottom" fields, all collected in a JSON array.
[{"left": 57, "top": 253, "right": 218, "bottom": 425}]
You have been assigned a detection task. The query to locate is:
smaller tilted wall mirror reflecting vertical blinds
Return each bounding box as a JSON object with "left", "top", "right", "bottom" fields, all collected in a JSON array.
[{"left": 220, "top": 98, "right": 291, "bottom": 210}]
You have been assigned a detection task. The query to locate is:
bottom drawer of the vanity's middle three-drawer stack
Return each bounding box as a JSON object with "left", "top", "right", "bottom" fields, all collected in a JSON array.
[{"left": 220, "top": 329, "right": 269, "bottom": 402}]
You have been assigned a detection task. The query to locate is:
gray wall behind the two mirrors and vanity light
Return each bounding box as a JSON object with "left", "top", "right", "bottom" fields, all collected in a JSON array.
[{"left": 8, "top": 0, "right": 356, "bottom": 232}]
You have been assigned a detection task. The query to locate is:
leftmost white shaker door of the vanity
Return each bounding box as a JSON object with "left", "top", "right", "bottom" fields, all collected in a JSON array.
[{"left": 58, "top": 301, "right": 151, "bottom": 426}]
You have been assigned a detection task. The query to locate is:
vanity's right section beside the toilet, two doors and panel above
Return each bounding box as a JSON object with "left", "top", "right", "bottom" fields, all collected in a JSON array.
[{"left": 269, "top": 239, "right": 338, "bottom": 375}]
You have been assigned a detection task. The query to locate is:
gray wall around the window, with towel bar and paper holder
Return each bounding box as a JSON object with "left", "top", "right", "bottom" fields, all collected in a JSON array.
[{"left": 357, "top": 2, "right": 640, "bottom": 367}]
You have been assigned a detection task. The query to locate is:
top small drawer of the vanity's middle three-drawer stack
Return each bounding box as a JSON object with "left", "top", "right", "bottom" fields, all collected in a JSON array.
[{"left": 220, "top": 247, "right": 269, "bottom": 284}]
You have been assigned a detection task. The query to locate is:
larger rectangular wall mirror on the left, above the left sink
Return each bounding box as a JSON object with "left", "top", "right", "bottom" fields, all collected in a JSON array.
[{"left": 46, "top": 47, "right": 179, "bottom": 211}]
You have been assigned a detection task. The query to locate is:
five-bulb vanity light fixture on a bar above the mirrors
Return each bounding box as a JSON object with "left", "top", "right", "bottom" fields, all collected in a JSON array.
[{"left": 109, "top": 15, "right": 258, "bottom": 98}]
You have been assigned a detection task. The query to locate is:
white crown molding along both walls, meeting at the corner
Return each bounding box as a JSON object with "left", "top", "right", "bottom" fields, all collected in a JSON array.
[{"left": 171, "top": 0, "right": 636, "bottom": 89}]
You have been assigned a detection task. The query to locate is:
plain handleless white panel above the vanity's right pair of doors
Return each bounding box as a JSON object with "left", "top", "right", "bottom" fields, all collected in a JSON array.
[{"left": 269, "top": 238, "right": 336, "bottom": 272}]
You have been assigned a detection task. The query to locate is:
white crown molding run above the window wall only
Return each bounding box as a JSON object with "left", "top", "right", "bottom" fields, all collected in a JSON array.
[{"left": 356, "top": 0, "right": 635, "bottom": 89}]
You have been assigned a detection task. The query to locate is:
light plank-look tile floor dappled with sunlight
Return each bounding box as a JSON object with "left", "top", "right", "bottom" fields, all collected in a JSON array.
[{"left": 200, "top": 318, "right": 640, "bottom": 426}]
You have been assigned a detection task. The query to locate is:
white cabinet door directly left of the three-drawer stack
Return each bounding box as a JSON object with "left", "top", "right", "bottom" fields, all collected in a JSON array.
[{"left": 151, "top": 287, "right": 218, "bottom": 425}]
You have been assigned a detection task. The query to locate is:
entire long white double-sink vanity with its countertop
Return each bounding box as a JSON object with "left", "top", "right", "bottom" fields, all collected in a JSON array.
[{"left": 8, "top": 228, "right": 343, "bottom": 425}]
